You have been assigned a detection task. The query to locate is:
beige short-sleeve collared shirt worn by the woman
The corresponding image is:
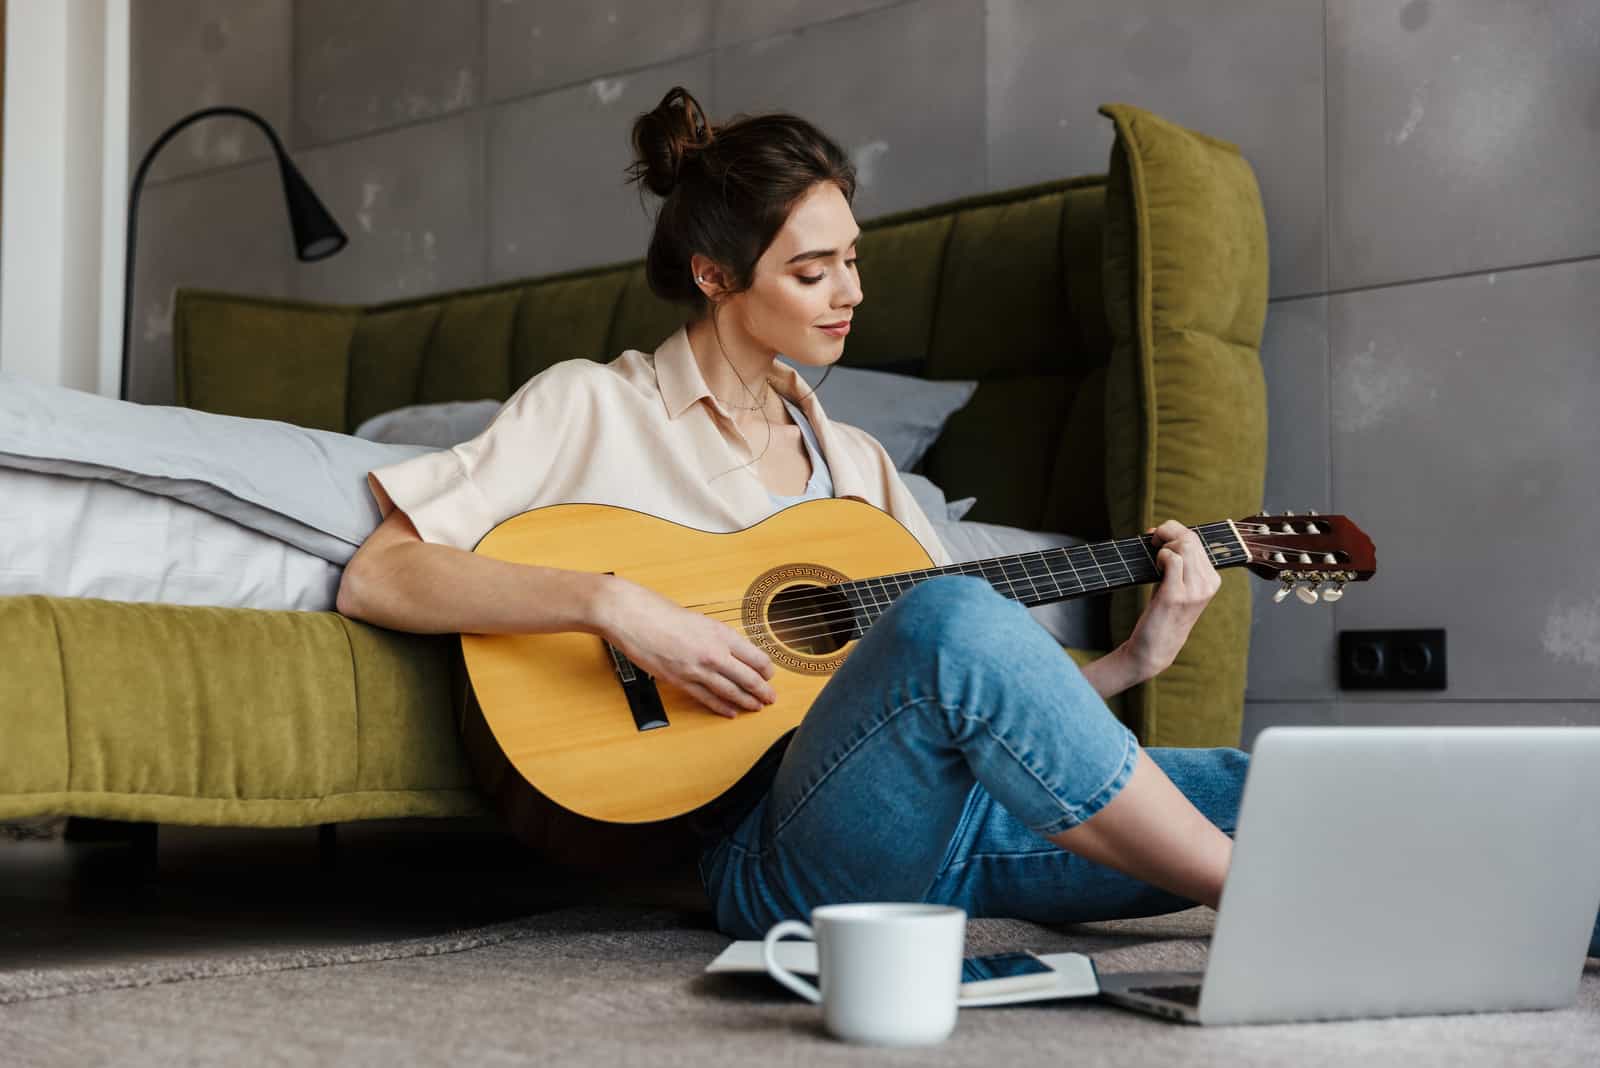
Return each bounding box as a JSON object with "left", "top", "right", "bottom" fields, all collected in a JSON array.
[{"left": 366, "top": 328, "right": 952, "bottom": 566}]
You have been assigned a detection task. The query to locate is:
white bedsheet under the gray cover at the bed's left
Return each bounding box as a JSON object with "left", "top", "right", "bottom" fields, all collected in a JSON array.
[{"left": 0, "top": 467, "right": 342, "bottom": 611}]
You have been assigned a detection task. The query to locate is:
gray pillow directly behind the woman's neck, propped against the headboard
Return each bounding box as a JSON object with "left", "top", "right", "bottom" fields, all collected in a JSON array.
[{"left": 782, "top": 358, "right": 978, "bottom": 472}]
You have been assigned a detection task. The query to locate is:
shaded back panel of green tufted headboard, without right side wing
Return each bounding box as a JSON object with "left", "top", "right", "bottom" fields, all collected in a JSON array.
[{"left": 174, "top": 176, "right": 1110, "bottom": 546}]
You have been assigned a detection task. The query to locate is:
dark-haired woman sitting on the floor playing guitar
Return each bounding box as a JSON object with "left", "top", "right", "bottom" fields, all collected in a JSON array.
[{"left": 339, "top": 88, "right": 1248, "bottom": 938}]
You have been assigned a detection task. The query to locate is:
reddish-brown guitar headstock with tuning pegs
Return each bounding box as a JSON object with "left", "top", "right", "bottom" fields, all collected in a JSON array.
[{"left": 1234, "top": 512, "right": 1378, "bottom": 604}]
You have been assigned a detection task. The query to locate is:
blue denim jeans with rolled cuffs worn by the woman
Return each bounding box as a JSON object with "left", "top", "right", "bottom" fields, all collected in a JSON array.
[{"left": 699, "top": 576, "right": 1600, "bottom": 956}]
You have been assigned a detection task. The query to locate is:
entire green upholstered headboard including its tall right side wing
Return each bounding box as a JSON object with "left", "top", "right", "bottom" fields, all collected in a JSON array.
[{"left": 173, "top": 104, "right": 1267, "bottom": 745}]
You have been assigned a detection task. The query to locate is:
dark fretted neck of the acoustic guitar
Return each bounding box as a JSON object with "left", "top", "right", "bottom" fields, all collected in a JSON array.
[{"left": 834, "top": 520, "right": 1250, "bottom": 633}]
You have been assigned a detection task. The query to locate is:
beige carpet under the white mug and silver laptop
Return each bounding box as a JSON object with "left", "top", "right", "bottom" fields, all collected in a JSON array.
[{"left": 0, "top": 907, "right": 1600, "bottom": 1068}]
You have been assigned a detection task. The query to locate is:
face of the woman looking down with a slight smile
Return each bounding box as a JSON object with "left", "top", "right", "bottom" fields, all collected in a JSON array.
[{"left": 722, "top": 182, "right": 861, "bottom": 366}]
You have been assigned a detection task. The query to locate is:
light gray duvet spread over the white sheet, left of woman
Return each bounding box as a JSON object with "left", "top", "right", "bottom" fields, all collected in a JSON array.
[{"left": 0, "top": 373, "right": 432, "bottom": 564}]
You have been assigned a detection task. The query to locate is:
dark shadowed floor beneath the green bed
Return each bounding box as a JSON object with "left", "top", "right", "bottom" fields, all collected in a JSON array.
[{"left": 0, "top": 819, "right": 710, "bottom": 967}]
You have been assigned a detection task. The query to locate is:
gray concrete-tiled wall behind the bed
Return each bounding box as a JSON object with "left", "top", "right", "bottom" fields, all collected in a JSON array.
[{"left": 131, "top": 0, "right": 1600, "bottom": 745}]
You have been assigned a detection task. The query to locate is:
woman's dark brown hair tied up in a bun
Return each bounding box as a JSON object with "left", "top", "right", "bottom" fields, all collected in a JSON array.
[{"left": 627, "top": 85, "right": 856, "bottom": 317}]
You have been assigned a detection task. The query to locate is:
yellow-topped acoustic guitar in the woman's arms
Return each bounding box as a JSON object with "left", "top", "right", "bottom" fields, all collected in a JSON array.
[{"left": 461, "top": 497, "right": 1376, "bottom": 823}]
